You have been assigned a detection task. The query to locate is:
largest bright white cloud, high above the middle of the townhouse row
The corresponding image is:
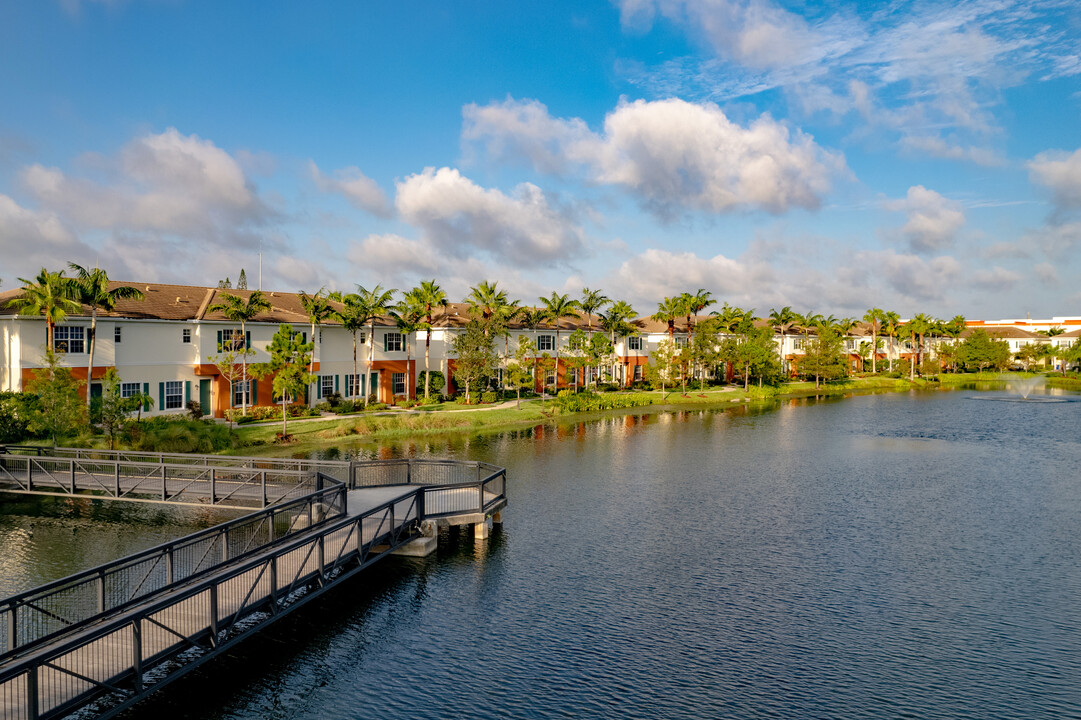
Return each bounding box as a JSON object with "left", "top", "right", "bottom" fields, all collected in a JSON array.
[{"left": 463, "top": 98, "right": 845, "bottom": 217}]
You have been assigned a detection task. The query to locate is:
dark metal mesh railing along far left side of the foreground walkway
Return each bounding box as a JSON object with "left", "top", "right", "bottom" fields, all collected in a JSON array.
[{"left": 0, "top": 478, "right": 346, "bottom": 659}]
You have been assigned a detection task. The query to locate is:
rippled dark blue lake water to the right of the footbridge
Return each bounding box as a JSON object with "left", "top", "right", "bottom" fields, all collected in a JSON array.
[{"left": 6, "top": 391, "right": 1081, "bottom": 720}]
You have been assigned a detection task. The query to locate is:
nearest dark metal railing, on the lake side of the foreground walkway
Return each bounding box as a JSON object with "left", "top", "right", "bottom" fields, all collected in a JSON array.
[{"left": 0, "top": 482, "right": 421, "bottom": 720}]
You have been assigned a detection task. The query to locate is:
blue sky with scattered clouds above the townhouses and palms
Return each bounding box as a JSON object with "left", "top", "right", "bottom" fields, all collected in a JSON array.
[{"left": 0, "top": 0, "right": 1081, "bottom": 318}]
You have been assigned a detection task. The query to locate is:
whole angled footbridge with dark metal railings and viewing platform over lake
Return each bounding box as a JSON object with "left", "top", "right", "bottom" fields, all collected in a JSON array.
[{"left": 0, "top": 445, "right": 507, "bottom": 720}]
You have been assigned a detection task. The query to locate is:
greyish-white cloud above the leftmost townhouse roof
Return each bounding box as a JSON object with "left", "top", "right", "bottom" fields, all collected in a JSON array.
[{"left": 22, "top": 128, "right": 272, "bottom": 241}]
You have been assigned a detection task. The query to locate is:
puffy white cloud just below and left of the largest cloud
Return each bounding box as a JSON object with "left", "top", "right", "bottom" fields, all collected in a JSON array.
[{"left": 395, "top": 168, "right": 585, "bottom": 264}]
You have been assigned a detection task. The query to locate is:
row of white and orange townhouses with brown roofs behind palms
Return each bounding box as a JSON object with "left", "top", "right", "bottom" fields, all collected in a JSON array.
[{"left": 0, "top": 282, "right": 1081, "bottom": 417}]
